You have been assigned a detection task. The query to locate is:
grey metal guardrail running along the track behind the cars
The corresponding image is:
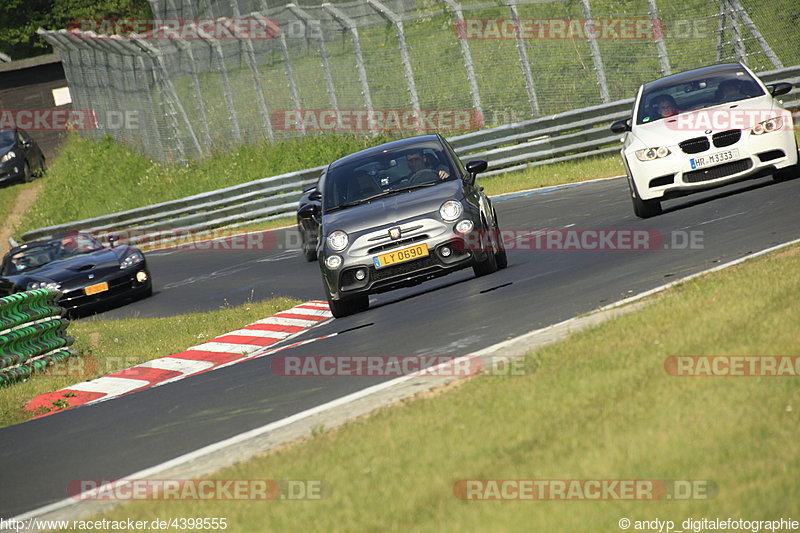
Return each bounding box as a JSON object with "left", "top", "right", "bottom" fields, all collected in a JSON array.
[{"left": 23, "top": 65, "right": 800, "bottom": 244}]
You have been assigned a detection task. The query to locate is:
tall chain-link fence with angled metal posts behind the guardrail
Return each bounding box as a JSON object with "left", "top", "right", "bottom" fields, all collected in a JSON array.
[{"left": 41, "top": 0, "right": 800, "bottom": 162}]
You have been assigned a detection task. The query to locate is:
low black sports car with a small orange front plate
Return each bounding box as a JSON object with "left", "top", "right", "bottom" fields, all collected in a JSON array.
[{"left": 0, "top": 232, "right": 153, "bottom": 315}]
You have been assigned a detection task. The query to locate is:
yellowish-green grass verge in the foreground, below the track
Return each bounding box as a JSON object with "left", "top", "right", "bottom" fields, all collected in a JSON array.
[{"left": 69, "top": 247, "right": 800, "bottom": 533}]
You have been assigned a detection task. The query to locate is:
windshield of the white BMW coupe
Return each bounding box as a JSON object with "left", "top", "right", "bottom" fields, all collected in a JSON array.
[{"left": 636, "top": 65, "right": 764, "bottom": 124}]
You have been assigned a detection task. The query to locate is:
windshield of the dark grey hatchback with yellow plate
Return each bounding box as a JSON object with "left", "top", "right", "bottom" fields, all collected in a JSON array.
[{"left": 323, "top": 143, "right": 454, "bottom": 212}]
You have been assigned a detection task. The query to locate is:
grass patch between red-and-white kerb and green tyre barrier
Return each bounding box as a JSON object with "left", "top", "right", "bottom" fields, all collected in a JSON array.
[{"left": 0, "top": 298, "right": 300, "bottom": 427}]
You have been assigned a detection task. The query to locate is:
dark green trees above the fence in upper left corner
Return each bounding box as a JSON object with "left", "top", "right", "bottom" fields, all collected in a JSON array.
[{"left": 0, "top": 0, "right": 153, "bottom": 59}]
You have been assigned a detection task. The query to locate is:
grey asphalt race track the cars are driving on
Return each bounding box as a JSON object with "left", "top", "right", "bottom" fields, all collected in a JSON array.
[{"left": 0, "top": 174, "right": 800, "bottom": 518}]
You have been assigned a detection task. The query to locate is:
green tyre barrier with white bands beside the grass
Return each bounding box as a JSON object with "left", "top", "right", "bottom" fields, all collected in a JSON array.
[{"left": 0, "top": 289, "right": 74, "bottom": 387}]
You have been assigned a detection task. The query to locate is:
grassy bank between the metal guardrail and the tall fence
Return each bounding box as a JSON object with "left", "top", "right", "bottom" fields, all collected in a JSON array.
[{"left": 15, "top": 135, "right": 394, "bottom": 235}]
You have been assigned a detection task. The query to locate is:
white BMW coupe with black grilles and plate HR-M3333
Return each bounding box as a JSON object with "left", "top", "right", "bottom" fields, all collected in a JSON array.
[{"left": 611, "top": 63, "right": 798, "bottom": 218}]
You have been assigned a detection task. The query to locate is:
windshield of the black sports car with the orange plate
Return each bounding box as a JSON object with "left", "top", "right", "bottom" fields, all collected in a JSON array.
[{"left": 2, "top": 233, "right": 103, "bottom": 276}]
